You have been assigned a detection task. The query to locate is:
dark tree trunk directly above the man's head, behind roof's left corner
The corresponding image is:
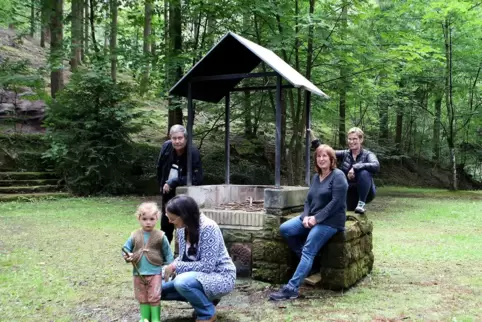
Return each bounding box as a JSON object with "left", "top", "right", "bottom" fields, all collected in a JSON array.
[{"left": 167, "top": 0, "right": 185, "bottom": 128}]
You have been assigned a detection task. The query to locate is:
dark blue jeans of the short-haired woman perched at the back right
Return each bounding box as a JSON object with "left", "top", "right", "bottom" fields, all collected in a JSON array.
[{"left": 346, "top": 170, "right": 376, "bottom": 211}]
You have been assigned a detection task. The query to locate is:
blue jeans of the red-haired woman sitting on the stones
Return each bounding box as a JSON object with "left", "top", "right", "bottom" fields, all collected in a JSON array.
[{"left": 280, "top": 216, "right": 338, "bottom": 291}]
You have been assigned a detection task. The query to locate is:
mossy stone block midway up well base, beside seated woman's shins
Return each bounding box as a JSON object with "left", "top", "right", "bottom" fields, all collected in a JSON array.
[{"left": 252, "top": 239, "right": 291, "bottom": 265}]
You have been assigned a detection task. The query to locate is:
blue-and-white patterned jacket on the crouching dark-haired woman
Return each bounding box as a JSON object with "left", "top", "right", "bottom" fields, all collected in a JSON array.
[{"left": 173, "top": 214, "right": 236, "bottom": 299}]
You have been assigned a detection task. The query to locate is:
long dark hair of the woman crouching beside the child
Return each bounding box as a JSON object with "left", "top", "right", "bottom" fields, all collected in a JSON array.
[{"left": 166, "top": 195, "right": 200, "bottom": 256}]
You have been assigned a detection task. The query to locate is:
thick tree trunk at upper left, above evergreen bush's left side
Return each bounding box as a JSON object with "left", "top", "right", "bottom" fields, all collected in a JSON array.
[{"left": 49, "top": 0, "right": 64, "bottom": 98}]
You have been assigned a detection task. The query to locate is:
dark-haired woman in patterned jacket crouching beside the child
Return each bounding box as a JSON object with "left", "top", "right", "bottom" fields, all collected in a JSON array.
[{"left": 161, "top": 195, "right": 236, "bottom": 322}]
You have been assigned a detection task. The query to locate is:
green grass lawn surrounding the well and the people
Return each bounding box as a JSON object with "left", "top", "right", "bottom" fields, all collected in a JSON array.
[{"left": 0, "top": 188, "right": 482, "bottom": 322}]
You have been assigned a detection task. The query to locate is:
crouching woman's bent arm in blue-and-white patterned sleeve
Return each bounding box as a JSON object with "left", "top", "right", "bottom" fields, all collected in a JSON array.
[{"left": 174, "top": 225, "right": 223, "bottom": 274}]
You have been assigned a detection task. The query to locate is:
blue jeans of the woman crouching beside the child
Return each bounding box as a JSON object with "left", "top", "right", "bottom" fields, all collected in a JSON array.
[{"left": 161, "top": 272, "right": 216, "bottom": 320}]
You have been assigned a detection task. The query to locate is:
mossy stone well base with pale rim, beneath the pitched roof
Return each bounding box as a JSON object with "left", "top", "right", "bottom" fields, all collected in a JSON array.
[{"left": 177, "top": 185, "right": 373, "bottom": 289}]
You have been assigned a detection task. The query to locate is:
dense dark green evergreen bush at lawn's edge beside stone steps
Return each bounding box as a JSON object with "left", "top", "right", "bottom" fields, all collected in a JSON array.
[{"left": 45, "top": 71, "right": 141, "bottom": 195}]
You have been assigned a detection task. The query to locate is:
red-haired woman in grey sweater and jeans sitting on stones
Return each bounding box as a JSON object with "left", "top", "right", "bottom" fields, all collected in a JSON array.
[{"left": 269, "top": 144, "right": 348, "bottom": 301}]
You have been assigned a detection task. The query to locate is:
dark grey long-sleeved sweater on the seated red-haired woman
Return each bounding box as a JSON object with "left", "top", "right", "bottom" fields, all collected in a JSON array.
[{"left": 301, "top": 169, "right": 348, "bottom": 230}]
